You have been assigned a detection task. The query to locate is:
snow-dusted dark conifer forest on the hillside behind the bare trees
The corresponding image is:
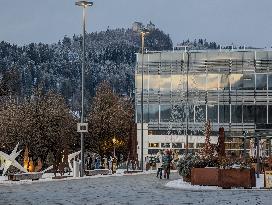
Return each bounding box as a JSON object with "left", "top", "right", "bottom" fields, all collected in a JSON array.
[{"left": 0, "top": 29, "right": 172, "bottom": 109}]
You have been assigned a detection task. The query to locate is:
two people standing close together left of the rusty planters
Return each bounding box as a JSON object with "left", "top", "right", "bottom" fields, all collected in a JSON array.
[{"left": 156, "top": 149, "right": 173, "bottom": 179}]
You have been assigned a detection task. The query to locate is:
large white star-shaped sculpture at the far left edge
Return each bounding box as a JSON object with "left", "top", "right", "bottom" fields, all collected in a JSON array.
[{"left": 0, "top": 143, "right": 28, "bottom": 175}]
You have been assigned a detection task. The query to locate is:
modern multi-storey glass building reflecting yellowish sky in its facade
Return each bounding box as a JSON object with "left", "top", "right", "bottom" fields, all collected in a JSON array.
[{"left": 135, "top": 50, "right": 272, "bottom": 159}]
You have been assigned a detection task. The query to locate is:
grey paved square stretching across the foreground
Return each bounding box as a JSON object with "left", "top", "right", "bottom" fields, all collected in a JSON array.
[{"left": 0, "top": 173, "right": 272, "bottom": 205}]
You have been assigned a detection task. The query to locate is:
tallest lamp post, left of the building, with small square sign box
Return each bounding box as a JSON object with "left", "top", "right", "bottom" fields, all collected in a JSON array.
[{"left": 75, "top": 1, "right": 93, "bottom": 177}]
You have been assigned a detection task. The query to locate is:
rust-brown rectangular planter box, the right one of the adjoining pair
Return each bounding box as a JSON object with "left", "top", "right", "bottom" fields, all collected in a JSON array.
[{"left": 218, "top": 169, "right": 256, "bottom": 188}]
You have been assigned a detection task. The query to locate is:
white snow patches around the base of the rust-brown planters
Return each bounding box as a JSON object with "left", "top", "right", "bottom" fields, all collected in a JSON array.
[{"left": 165, "top": 174, "right": 264, "bottom": 190}]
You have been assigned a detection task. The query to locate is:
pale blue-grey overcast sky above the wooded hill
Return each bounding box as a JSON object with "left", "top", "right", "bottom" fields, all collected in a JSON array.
[{"left": 0, "top": 0, "right": 272, "bottom": 47}]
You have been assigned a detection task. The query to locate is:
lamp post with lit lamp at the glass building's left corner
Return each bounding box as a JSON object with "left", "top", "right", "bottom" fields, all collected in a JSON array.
[{"left": 141, "top": 31, "right": 149, "bottom": 171}]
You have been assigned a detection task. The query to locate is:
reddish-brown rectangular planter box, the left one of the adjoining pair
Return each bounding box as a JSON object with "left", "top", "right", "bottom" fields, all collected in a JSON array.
[{"left": 191, "top": 168, "right": 219, "bottom": 186}]
